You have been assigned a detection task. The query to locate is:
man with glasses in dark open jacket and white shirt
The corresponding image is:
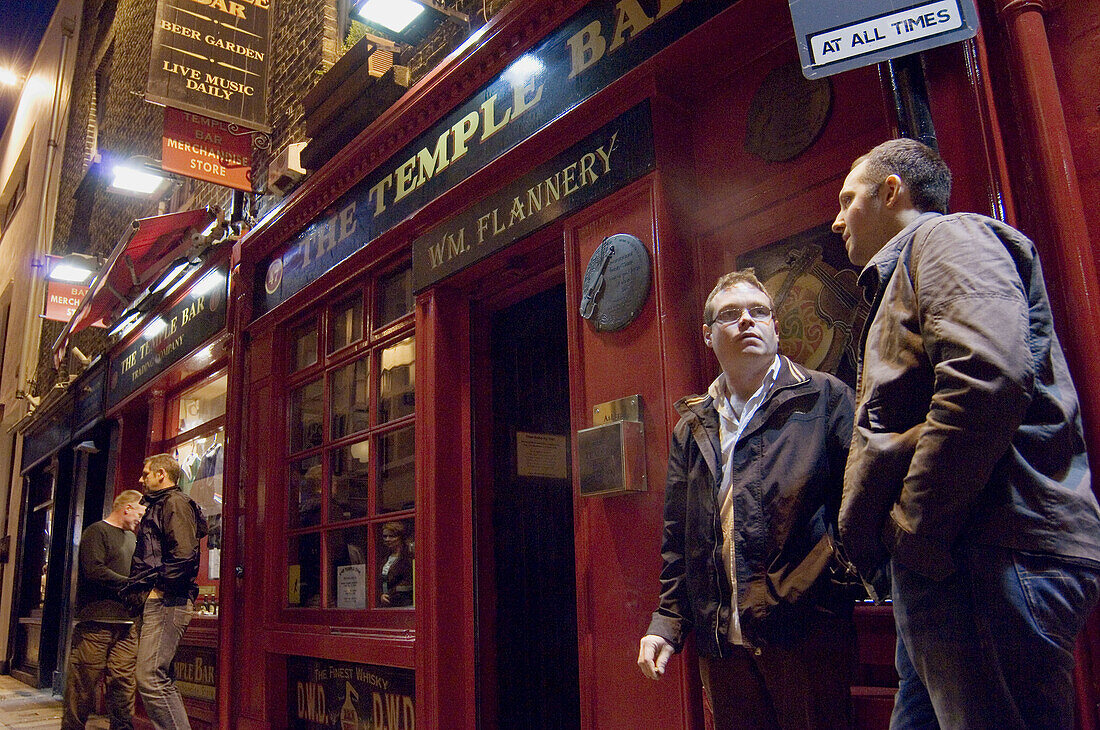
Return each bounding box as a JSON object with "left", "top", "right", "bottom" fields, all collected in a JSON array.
[{"left": 638, "top": 269, "right": 855, "bottom": 730}]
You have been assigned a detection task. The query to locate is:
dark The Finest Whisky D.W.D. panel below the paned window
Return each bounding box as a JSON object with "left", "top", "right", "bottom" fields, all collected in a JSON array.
[{"left": 286, "top": 656, "right": 416, "bottom": 730}]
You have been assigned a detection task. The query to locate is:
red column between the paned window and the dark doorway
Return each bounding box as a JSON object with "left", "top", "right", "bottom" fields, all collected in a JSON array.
[{"left": 415, "top": 288, "right": 477, "bottom": 728}]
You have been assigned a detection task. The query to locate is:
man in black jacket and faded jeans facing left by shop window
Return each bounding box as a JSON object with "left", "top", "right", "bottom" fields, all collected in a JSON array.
[{"left": 123, "top": 454, "right": 207, "bottom": 728}]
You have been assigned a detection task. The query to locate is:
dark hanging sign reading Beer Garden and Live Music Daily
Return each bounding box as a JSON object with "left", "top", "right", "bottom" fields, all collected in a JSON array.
[{"left": 145, "top": 0, "right": 271, "bottom": 132}]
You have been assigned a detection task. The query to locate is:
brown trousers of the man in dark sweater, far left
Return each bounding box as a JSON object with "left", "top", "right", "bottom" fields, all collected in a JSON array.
[{"left": 62, "top": 621, "right": 138, "bottom": 730}]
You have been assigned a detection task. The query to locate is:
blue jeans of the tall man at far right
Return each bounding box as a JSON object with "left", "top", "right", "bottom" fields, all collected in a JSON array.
[{"left": 890, "top": 545, "right": 1100, "bottom": 730}]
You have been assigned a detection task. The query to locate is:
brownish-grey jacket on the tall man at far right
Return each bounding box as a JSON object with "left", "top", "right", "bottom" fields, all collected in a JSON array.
[{"left": 839, "top": 213, "right": 1100, "bottom": 580}]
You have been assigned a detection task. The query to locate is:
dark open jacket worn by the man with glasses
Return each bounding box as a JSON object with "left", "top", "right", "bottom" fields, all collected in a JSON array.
[{"left": 647, "top": 357, "right": 853, "bottom": 656}]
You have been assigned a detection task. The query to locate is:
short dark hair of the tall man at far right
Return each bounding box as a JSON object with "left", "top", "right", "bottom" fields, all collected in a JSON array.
[{"left": 851, "top": 137, "right": 952, "bottom": 213}]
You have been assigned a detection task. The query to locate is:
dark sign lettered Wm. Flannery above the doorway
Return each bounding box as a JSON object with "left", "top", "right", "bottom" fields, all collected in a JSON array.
[{"left": 413, "top": 102, "right": 655, "bottom": 291}]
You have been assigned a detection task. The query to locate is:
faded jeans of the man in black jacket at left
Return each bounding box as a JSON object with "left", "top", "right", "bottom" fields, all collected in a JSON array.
[{"left": 134, "top": 598, "right": 193, "bottom": 730}]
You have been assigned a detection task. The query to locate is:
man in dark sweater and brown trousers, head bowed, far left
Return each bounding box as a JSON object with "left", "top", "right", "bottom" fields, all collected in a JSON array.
[{"left": 62, "top": 489, "right": 145, "bottom": 730}]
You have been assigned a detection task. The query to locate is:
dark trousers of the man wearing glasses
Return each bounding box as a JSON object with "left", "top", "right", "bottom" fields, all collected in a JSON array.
[{"left": 699, "top": 613, "right": 856, "bottom": 730}]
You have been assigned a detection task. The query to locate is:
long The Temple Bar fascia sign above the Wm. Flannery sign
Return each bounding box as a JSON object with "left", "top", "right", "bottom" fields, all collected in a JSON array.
[{"left": 255, "top": 0, "right": 734, "bottom": 317}]
